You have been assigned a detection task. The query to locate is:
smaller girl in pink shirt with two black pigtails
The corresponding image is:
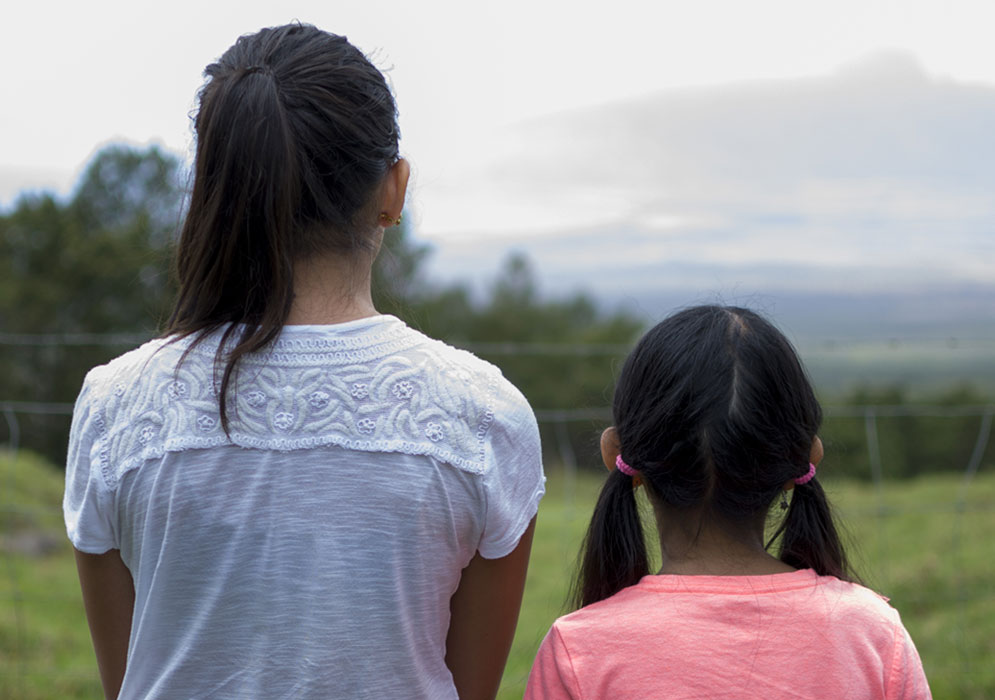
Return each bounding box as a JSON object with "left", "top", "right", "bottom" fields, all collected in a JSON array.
[{"left": 526, "top": 306, "right": 930, "bottom": 700}]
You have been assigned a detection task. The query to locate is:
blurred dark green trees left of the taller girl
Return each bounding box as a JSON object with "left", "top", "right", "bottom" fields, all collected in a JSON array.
[{"left": 0, "top": 146, "right": 183, "bottom": 461}]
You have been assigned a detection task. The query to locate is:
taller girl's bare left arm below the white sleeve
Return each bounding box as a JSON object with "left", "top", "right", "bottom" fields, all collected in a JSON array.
[{"left": 73, "top": 549, "right": 135, "bottom": 700}]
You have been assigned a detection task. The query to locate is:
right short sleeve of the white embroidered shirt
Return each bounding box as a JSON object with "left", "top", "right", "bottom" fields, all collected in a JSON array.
[{"left": 477, "top": 382, "right": 546, "bottom": 559}]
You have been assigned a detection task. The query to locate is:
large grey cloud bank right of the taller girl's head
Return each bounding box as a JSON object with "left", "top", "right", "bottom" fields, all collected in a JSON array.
[{"left": 425, "top": 52, "right": 995, "bottom": 296}]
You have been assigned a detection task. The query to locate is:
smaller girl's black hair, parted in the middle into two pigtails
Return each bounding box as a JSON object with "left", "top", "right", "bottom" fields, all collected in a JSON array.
[{"left": 575, "top": 306, "right": 852, "bottom": 606}]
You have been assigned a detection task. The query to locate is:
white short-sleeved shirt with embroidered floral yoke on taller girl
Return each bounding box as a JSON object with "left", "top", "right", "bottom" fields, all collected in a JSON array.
[{"left": 63, "top": 316, "right": 544, "bottom": 700}]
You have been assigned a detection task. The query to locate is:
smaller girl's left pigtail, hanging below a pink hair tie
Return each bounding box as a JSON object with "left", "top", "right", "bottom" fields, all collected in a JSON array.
[{"left": 572, "top": 470, "right": 649, "bottom": 608}]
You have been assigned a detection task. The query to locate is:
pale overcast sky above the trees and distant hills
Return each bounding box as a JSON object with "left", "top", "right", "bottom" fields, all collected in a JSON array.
[{"left": 0, "top": 0, "right": 995, "bottom": 308}]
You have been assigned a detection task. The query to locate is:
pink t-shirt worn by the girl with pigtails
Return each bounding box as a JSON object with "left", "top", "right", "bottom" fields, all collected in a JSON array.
[{"left": 525, "top": 569, "right": 931, "bottom": 700}]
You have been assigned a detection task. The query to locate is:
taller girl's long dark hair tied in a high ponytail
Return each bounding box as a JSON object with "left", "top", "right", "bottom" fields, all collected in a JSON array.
[{"left": 165, "top": 24, "right": 399, "bottom": 432}]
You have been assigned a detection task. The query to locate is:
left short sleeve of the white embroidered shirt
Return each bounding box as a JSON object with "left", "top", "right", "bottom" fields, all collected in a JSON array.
[{"left": 62, "top": 372, "right": 119, "bottom": 554}]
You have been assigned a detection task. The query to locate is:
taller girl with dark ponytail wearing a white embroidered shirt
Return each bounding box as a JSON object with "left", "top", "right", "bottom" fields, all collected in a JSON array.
[{"left": 64, "top": 24, "right": 544, "bottom": 700}]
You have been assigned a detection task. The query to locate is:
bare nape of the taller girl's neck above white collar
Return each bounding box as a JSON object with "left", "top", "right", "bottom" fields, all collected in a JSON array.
[{"left": 287, "top": 252, "right": 377, "bottom": 326}]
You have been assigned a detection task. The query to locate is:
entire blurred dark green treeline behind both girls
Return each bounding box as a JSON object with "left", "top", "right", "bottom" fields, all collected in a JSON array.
[{"left": 0, "top": 146, "right": 995, "bottom": 479}]
